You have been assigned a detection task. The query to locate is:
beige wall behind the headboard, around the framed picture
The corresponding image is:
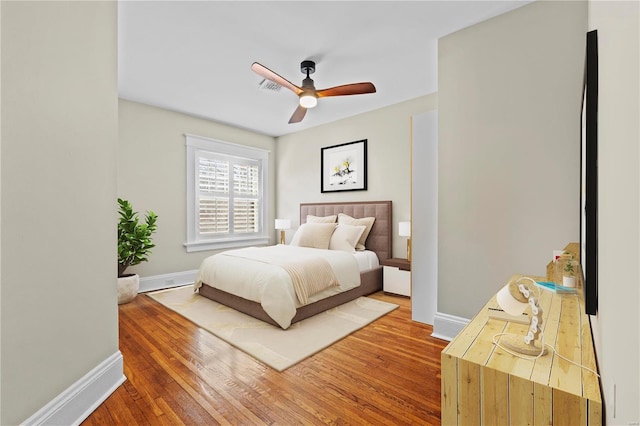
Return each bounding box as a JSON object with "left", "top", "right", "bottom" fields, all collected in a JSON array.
[{"left": 276, "top": 94, "right": 438, "bottom": 257}]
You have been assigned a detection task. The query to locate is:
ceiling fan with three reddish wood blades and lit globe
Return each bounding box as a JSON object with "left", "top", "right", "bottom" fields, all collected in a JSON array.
[{"left": 251, "top": 61, "right": 376, "bottom": 124}]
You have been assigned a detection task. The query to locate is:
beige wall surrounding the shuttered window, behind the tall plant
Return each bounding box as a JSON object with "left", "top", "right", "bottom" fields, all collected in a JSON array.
[{"left": 119, "top": 99, "right": 275, "bottom": 277}]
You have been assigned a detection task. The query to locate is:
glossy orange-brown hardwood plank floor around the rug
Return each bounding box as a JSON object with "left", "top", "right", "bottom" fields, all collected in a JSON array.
[{"left": 83, "top": 293, "right": 447, "bottom": 426}]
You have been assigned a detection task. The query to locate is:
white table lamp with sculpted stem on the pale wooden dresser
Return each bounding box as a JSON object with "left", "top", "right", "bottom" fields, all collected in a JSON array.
[{"left": 496, "top": 277, "right": 547, "bottom": 356}]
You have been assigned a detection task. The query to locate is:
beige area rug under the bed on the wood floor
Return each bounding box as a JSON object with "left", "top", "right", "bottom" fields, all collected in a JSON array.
[{"left": 148, "top": 285, "right": 398, "bottom": 371}]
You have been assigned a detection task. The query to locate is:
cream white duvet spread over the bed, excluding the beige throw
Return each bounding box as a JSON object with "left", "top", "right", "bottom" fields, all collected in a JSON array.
[{"left": 194, "top": 244, "right": 360, "bottom": 329}]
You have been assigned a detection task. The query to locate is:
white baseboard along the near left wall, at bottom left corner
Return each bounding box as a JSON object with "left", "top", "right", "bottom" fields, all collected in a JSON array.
[{"left": 22, "top": 351, "right": 127, "bottom": 425}]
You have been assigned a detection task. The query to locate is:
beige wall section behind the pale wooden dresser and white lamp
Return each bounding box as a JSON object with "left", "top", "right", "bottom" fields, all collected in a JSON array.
[{"left": 438, "top": 1, "right": 587, "bottom": 318}]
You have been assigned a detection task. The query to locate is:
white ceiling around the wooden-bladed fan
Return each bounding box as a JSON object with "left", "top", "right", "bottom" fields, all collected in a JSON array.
[{"left": 118, "top": 0, "right": 529, "bottom": 136}]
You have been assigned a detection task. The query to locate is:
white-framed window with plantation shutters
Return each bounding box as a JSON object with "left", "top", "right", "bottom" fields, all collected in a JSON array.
[{"left": 185, "top": 135, "right": 269, "bottom": 252}]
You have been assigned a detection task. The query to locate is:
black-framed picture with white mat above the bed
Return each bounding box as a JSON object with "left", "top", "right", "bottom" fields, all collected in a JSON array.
[{"left": 320, "top": 139, "right": 367, "bottom": 192}]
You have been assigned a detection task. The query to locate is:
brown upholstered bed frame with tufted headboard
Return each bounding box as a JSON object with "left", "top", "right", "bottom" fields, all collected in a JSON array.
[{"left": 199, "top": 201, "right": 393, "bottom": 327}]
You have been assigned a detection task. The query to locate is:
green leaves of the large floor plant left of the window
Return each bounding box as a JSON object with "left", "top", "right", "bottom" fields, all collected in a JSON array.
[{"left": 118, "top": 198, "right": 158, "bottom": 277}]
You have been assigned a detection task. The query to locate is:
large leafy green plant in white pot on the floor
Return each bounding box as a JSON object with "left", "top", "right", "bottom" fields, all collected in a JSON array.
[{"left": 118, "top": 198, "right": 158, "bottom": 305}]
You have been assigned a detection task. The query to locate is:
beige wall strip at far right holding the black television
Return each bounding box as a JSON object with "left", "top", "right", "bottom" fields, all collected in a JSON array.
[{"left": 589, "top": 1, "right": 640, "bottom": 425}]
